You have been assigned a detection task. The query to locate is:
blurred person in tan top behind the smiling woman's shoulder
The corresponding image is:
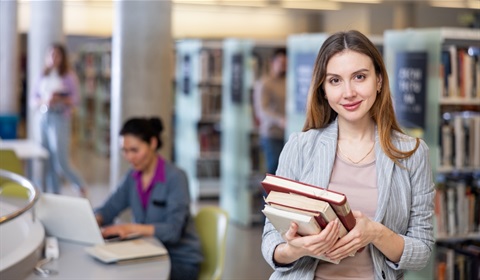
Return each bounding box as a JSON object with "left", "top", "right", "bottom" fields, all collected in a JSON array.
[{"left": 254, "top": 48, "right": 287, "bottom": 174}]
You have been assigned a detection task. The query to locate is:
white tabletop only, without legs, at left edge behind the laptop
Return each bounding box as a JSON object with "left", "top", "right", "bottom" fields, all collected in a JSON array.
[{"left": 0, "top": 139, "right": 48, "bottom": 159}]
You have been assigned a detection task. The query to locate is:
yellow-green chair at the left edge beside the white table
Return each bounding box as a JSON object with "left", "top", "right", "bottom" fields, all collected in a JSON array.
[{"left": 0, "top": 149, "right": 29, "bottom": 198}]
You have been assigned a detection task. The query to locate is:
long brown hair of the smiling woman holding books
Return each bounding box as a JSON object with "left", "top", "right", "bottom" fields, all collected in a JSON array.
[{"left": 303, "top": 30, "right": 420, "bottom": 164}]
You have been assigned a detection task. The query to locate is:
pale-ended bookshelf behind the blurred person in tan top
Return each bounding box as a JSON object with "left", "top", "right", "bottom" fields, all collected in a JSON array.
[{"left": 220, "top": 38, "right": 285, "bottom": 226}]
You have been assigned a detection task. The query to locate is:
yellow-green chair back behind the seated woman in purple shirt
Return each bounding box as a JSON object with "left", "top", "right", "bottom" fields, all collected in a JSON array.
[{"left": 195, "top": 206, "right": 229, "bottom": 280}]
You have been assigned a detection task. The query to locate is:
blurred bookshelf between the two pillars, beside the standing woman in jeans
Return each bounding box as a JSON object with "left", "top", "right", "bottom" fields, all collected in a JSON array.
[{"left": 75, "top": 42, "right": 111, "bottom": 156}]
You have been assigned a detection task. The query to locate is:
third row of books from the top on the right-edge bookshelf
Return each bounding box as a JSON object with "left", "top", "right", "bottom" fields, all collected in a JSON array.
[{"left": 435, "top": 173, "right": 480, "bottom": 239}]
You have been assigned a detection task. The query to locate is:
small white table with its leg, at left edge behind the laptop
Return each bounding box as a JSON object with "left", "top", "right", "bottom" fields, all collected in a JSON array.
[{"left": 0, "top": 139, "right": 49, "bottom": 190}]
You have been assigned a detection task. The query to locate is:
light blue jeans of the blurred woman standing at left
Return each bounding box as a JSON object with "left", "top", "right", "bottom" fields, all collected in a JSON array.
[{"left": 41, "top": 111, "right": 85, "bottom": 193}]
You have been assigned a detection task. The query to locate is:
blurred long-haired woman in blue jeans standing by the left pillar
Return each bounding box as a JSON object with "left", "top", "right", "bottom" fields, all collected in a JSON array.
[{"left": 33, "top": 43, "right": 87, "bottom": 197}]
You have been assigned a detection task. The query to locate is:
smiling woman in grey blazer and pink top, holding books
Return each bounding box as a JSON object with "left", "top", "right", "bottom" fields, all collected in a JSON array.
[{"left": 262, "top": 31, "right": 434, "bottom": 279}]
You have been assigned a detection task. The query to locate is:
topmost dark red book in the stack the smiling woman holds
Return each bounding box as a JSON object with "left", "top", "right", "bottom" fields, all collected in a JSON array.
[{"left": 261, "top": 173, "right": 355, "bottom": 231}]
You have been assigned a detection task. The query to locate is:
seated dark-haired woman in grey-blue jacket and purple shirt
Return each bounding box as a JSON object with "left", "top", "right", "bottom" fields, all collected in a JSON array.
[{"left": 95, "top": 118, "right": 203, "bottom": 279}]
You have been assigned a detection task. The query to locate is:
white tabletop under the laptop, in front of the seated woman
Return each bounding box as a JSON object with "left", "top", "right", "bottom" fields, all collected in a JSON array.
[{"left": 26, "top": 240, "right": 170, "bottom": 280}]
